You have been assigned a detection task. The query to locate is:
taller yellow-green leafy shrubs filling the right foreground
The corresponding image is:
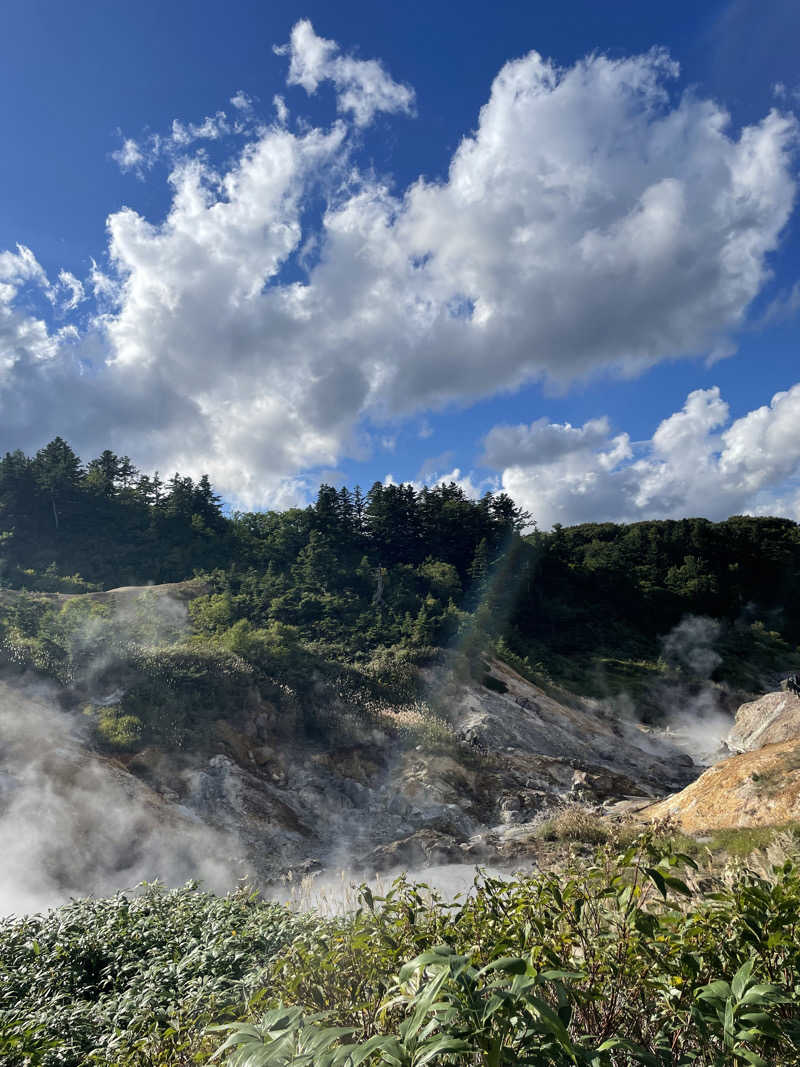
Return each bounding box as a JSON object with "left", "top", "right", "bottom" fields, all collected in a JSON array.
[{"left": 214, "top": 834, "right": 800, "bottom": 1067}]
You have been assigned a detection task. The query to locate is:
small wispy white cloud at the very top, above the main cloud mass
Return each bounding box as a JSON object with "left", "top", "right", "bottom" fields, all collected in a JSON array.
[{"left": 275, "top": 18, "right": 414, "bottom": 126}]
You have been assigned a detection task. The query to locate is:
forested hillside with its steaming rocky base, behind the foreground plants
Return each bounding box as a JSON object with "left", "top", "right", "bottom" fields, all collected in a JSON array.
[{"left": 0, "top": 439, "right": 800, "bottom": 906}]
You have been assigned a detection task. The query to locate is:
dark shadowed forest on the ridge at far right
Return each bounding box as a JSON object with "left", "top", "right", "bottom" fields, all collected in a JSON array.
[{"left": 513, "top": 515, "right": 800, "bottom": 674}]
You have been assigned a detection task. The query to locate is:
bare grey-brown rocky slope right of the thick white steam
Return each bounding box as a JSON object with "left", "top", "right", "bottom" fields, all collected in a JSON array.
[{"left": 134, "top": 663, "right": 699, "bottom": 878}]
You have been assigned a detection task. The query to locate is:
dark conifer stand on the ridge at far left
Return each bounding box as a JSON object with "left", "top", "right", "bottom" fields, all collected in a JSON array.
[{"left": 0, "top": 437, "right": 227, "bottom": 592}]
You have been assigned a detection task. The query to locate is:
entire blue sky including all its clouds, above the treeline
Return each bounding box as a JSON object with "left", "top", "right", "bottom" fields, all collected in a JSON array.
[{"left": 0, "top": 0, "right": 800, "bottom": 526}]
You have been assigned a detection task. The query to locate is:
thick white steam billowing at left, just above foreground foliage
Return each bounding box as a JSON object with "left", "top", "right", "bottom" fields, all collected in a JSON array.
[{"left": 0, "top": 679, "right": 246, "bottom": 914}]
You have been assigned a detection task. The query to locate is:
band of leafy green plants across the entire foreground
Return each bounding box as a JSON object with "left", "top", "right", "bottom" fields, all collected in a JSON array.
[{"left": 0, "top": 835, "right": 800, "bottom": 1067}]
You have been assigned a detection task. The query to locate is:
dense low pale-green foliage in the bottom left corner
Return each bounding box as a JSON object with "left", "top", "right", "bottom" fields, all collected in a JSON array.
[{"left": 0, "top": 885, "right": 310, "bottom": 1067}]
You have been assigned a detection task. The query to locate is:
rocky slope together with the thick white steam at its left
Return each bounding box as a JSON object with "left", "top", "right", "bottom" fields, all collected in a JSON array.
[{"left": 0, "top": 623, "right": 700, "bottom": 910}]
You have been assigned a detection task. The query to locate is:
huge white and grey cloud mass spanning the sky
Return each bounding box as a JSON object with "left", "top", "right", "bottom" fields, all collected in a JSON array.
[{"left": 0, "top": 21, "right": 797, "bottom": 506}]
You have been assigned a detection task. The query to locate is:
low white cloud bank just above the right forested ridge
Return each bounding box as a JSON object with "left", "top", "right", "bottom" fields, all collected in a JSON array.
[{"left": 492, "top": 384, "right": 800, "bottom": 527}]
